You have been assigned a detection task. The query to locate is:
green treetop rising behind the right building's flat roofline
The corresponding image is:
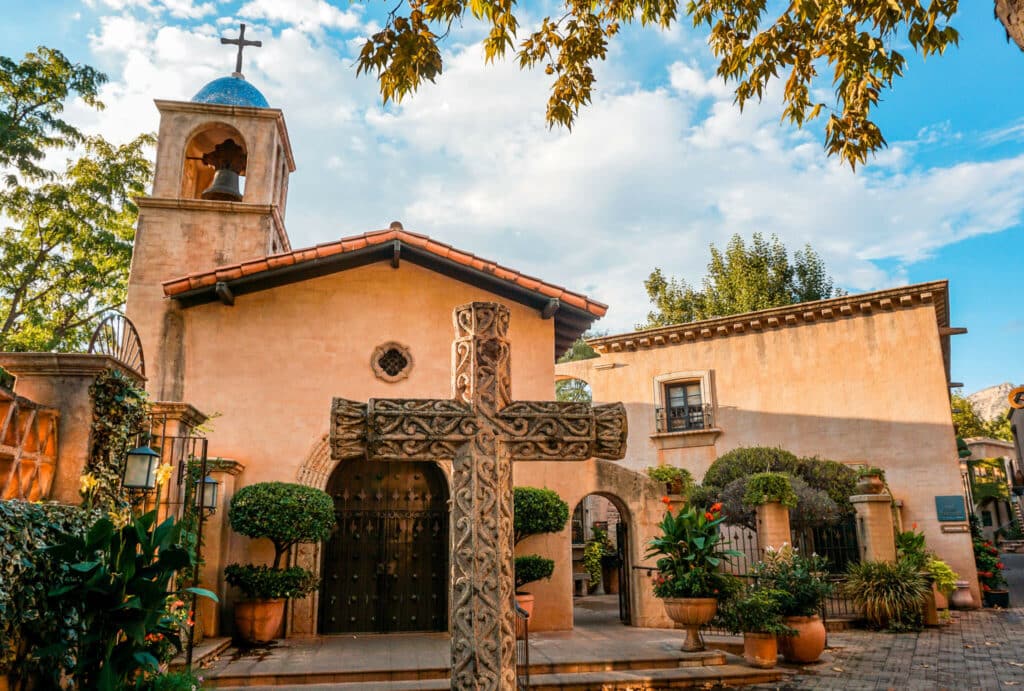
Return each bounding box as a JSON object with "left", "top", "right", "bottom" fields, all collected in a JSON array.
[{"left": 638, "top": 232, "right": 843, "bottom": 329}]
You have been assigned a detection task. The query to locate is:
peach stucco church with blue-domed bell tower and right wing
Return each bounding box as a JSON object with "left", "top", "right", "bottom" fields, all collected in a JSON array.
[{"left": 119, "top": 51, "right": 978, "bottom": 636}]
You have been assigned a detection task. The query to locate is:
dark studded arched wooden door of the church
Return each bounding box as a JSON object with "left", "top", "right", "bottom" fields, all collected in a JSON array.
[{"left": 319, "top": 461, "right": 449, "bottom": 634}]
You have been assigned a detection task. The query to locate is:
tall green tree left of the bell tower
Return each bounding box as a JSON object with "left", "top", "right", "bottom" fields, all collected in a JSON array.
[{"left": 0, "top": 47, "right": 155, "bottom": 350}]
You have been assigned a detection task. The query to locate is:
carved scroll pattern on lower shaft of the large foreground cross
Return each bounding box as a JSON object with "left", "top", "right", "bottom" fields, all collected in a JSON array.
[{"left": 452, "top": 426, "right": 515, "bottom": 691}]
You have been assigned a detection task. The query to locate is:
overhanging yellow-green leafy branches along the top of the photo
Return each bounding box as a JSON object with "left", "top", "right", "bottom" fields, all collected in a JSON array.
[{"left": 357, "top": 0, "right": 966, "bottom": 167}]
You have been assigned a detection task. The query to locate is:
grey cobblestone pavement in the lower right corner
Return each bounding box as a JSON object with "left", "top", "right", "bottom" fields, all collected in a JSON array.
[{"left": 754, "top": 609, "right": 1024, "bottom": 691}]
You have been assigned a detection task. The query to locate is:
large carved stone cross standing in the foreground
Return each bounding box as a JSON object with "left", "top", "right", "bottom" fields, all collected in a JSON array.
[{"left": 331, "top": 302, "right": 627, "bottom": 691}]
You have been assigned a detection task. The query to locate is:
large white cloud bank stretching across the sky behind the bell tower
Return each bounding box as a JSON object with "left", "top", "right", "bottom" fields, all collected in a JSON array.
[{"left": 75, "top": 10, "right": 1024, "bottom": 330}]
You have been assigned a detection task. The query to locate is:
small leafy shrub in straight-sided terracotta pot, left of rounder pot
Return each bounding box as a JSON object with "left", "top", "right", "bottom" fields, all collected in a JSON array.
[{"left": 718, "top": 585, "right": 796, "bottom": 670}]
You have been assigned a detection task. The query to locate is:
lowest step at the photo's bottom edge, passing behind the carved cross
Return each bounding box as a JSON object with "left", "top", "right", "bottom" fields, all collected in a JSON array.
[{"left": 219, "top": 663, "right": 794, "bottom": 691}]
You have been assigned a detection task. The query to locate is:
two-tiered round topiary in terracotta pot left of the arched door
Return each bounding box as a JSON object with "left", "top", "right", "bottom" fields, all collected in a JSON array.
[{"left": 224, "top": 482, "right": 335, "bottom": 643}]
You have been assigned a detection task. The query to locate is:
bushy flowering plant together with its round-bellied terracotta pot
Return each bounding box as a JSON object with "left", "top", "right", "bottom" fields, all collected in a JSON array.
[{"left": 754, "top": 545, "right": 831, "bottom": 662}]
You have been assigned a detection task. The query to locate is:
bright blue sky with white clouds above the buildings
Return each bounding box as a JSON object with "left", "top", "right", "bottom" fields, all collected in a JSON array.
[{"left": 0, "top": 0, "right": 1024, "bottom": 392}]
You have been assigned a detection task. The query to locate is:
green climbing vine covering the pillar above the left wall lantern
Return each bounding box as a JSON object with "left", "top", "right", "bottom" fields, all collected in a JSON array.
[{"left": 82, "top": 370, "right": 148, "bottom": 512}]
